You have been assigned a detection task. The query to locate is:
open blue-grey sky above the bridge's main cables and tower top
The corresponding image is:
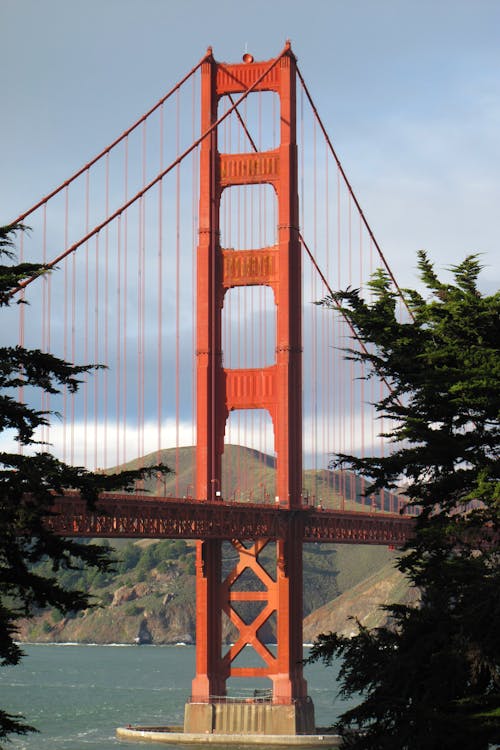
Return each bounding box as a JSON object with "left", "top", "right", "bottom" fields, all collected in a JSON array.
[{"left": 0, "top": 0, "right": 500, "bottom": 290}]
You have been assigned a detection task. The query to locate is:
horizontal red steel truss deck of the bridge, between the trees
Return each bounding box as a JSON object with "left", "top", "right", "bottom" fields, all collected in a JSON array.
[{"left": 46, "top": 493, "right": 415, "bottom": 547}]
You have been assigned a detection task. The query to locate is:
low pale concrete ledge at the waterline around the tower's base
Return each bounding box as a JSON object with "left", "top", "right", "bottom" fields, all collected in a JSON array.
[{"left": 116, "top": 726, "right": 341, "bottom": 748}]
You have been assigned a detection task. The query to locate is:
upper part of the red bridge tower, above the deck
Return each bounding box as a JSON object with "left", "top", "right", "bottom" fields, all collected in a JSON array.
[{"left": 196, "top": 42, "right": 302, "bottom": 507}]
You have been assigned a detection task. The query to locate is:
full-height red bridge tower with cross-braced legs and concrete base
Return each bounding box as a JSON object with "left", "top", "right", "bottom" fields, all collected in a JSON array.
[{"left": 185, "top": 43, "right": 314, "bottom": 734}]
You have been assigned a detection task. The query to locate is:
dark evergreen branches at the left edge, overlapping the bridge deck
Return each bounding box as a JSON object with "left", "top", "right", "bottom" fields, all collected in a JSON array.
[{"left": 0, "top": 225, "right": 168, "bottom": 740}]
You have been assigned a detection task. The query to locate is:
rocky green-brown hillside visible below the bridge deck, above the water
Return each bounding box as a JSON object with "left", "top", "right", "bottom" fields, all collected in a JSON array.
[{"left": 19, "top": 540, "right": 408, "bottom": 644}]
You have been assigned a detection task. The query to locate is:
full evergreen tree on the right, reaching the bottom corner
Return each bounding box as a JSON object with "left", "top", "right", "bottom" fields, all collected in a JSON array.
[{"left": 311, "top": 252, "right": 500, "bottom": 750}]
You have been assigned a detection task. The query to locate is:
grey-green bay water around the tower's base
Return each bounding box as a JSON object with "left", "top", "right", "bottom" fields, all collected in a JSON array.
[{"left": 0, "top": 644, "right": 349, "bottom": 750}]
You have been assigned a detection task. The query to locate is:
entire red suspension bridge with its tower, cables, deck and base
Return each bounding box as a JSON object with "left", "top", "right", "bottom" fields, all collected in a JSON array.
[{"left": 4, "top": 43, "right": 412, "bottom": 735}]
